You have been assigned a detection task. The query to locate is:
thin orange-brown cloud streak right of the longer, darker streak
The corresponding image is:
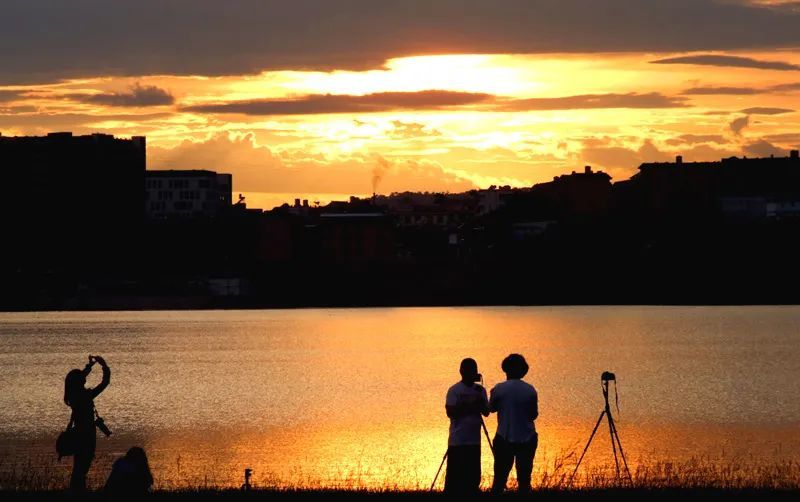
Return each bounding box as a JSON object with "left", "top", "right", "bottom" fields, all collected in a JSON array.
[{"left": 498, "top": 92, "right": 689, "bottom": 111}]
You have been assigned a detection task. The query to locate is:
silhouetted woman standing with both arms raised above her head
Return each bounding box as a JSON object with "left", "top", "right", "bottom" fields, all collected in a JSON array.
[{"left": 64, "top": 356, "right": 111, "bottom": 492}]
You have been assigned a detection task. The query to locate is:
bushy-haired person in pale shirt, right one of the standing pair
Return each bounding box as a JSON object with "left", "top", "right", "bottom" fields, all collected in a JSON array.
[{"left": 489, "top": 354, "right": 539, "bottom": 494}]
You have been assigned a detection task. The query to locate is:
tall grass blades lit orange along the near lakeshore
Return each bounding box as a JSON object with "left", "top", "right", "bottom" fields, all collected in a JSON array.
[{"left": 0, "top": 452, "right": 800, "bottom": 493}]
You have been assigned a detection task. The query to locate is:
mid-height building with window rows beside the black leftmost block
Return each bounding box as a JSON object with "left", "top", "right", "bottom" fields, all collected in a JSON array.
[{"left": 145, "top": 170, "right": 232, "bottom": 220}]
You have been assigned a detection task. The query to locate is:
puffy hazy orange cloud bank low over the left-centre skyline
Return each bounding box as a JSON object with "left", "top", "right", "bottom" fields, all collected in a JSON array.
[{"left": 148, "top": 134, "right": 475, "bottom": 194}]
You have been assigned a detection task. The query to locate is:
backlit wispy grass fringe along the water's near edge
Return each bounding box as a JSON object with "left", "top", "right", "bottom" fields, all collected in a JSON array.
[{"left": 0, "top": 454, "right": 800, "bottom": 494}]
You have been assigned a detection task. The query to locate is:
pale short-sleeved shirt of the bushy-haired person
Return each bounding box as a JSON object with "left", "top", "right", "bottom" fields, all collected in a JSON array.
[{"left": 489, "top": 380, "right": 539, "bottom": 443}]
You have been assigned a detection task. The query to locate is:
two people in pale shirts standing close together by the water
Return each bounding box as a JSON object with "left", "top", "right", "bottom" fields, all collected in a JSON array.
[{"left": 444, "top": 354, "right": 539, "bottom": 494}]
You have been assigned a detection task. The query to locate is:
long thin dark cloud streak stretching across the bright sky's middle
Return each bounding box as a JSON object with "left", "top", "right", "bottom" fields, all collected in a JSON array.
[{"left": 184, "top": 90, "right": 689, "bottom": 115}]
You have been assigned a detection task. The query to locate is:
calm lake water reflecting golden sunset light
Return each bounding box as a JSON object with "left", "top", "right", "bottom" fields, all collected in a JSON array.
[{"left": 0, "top": 307, "right": 800, "bottom": 488}]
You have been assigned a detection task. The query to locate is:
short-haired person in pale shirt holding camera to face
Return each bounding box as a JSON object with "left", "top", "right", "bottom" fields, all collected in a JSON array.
[{"left": 444, "top": 357, "right": 489, "bottom": 494}]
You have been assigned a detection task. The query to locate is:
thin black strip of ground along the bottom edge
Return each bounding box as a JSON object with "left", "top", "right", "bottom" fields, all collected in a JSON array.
[{"left": 0, "top": 488, "right": 800, "bottom": 502}]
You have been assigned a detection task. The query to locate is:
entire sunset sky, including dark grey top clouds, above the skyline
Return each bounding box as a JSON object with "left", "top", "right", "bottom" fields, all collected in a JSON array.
[{"left": 0, "top": 0, "right": 800, "bottom": 208}]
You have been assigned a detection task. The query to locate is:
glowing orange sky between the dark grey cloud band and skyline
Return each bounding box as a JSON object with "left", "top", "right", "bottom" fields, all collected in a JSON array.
[{"left": 0, "top": 0, "right": 800, "bottom": 207}]
